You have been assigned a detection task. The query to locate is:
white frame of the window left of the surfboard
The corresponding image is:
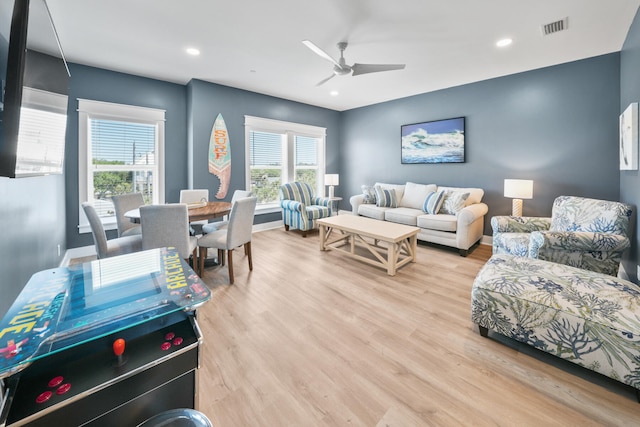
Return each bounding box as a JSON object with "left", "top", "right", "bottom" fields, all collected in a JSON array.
[{"left": 78, "top": 98, "right": 166, "bottom": 234}]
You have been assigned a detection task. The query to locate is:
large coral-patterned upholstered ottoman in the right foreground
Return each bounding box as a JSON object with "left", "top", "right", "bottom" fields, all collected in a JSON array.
[{"left": 471, "top": 254, "right": 640, "bottom": 396}]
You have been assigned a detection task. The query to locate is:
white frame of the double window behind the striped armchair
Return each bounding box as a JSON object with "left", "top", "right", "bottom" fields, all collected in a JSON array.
[{"left": 244, "top": 115, "right": 327, "bottom": 215}]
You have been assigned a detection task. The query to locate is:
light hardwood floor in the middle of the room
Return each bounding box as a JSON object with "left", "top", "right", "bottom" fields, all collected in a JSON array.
[{"left": 198, "top": 229, "right": 640, "bottom": 427}]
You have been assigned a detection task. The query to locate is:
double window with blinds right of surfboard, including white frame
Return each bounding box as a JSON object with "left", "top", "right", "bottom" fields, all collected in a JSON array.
[{"left": 245, "top": 116, "right": 326, "bottom": 211}]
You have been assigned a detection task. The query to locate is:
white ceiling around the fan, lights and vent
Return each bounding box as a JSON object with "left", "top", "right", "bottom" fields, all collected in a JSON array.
[{"left": 47, "top": 0, "right": 640, "bottom": 111}]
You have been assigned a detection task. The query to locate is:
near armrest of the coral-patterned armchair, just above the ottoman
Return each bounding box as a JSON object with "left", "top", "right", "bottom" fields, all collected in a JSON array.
[{"left": 529, "top": 231, "right": 631, "bottom": 254}]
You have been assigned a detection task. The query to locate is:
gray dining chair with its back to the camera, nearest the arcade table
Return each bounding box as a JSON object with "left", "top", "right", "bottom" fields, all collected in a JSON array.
[{"left": 140, "top": 203, "right": 198, "bottom": 268}]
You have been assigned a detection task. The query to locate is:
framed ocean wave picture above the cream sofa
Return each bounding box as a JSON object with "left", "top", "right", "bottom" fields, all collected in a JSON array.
[{"left": 400, "top": 117, "right": 465, "bottom": 164}]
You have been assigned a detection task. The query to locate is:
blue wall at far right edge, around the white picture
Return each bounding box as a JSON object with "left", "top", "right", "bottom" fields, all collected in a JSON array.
[{"left": 619, "top": 6, "right": 640, "bottom": 283}]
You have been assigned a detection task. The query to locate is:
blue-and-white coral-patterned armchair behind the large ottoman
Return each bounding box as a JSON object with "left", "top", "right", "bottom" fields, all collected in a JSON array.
[{"left": 491, "top": 196, "right": 632, "bottom": 276}]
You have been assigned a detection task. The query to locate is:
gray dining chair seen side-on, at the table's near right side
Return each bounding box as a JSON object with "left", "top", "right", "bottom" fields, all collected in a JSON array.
[{"left": 198, "top": 197, "right": 258, "bottom": 284}]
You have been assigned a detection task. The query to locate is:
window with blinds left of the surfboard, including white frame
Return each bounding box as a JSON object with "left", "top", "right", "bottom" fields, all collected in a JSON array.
[{"left": 78, "top": 100, "right": 164, "bottom": 231}]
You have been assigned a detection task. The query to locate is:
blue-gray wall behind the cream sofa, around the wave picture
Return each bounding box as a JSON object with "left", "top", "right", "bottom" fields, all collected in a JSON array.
[{"left": 340, "top": 53, "right": 620, "bottom": 235}]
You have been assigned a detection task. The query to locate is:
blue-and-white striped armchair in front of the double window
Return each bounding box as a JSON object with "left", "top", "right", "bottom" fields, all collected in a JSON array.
[{"left": 280, "top": 181, "right": 331, "bottom": 237}]
